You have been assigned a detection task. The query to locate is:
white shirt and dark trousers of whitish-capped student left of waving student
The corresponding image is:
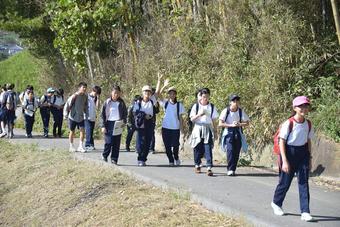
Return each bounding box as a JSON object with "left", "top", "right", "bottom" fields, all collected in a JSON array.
[{"left": 133, "top": 100, "right": 155, "bottom": 165}]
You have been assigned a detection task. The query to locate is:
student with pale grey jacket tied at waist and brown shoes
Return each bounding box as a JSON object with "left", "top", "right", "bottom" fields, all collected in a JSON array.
[{"left": 190, "top": 88, "right": 218, "bottom": 176}]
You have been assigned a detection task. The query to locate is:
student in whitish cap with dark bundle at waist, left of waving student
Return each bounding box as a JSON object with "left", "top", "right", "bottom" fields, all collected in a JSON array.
[{"left": 133, "top": 85, "right": 157, "bottom": 166}]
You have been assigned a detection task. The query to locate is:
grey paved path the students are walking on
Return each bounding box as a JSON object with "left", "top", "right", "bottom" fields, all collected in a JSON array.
[{"left": 7, "top": 130, "right": 340, "bottom": 227}]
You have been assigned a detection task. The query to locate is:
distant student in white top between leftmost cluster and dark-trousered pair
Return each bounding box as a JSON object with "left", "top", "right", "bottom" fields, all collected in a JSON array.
[{"left": 23, "top": 90, "right": 39, "bottom": 138}]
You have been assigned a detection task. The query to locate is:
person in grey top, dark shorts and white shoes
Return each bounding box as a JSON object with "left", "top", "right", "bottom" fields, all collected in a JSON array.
[{"left": 64, "top": 82, "right": 88, "bottom": 152}]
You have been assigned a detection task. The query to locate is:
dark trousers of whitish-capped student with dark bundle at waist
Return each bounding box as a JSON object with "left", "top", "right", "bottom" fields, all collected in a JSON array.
[{"left": 136, "top": 120, "right": 154, "bottom": 162}]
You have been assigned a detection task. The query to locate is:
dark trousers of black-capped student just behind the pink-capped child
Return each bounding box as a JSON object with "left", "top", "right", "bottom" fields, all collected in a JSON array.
[{"left": 225, "top": 130, "right": 242, "bottom": 171}]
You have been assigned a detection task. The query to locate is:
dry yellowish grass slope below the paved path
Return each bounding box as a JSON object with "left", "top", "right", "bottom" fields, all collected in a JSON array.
[{"left": 0, "top": 141, "right": 245, "bottom": 226}]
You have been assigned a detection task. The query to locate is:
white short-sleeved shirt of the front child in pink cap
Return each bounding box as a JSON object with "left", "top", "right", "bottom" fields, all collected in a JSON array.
[{"left": 279, "top": 120, "right": 314, "bottom": 146}]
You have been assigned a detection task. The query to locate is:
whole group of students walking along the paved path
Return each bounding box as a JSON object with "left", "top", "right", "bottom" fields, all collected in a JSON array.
[{"left": 0, "top": 75, "right": 313, "bottom": 221}]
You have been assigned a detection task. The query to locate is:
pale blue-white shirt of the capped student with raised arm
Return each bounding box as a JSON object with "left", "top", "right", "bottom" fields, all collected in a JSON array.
[{"left": 159, "top": 100, "right": 185, "bottom": 129}]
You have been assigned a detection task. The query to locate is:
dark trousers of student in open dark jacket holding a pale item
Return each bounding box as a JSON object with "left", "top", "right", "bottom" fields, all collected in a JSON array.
[{"left": 103, "top": 121, "right": 122, "bottom": 162}]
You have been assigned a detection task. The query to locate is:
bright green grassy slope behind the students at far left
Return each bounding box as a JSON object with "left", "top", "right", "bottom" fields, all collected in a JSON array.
[{"left": 0, "top": 50, "right": 50, "bottom": 94}]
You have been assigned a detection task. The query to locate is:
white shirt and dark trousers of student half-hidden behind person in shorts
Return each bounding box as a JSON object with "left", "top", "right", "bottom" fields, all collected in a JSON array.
[{"left": 85, "top": 94, "right": 97, "bottom": 148}]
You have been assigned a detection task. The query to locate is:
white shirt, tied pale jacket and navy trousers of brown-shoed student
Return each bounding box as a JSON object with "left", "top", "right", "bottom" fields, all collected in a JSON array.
[{"left": 189, "top": 103, "right": 218, "bottom": 168}]
